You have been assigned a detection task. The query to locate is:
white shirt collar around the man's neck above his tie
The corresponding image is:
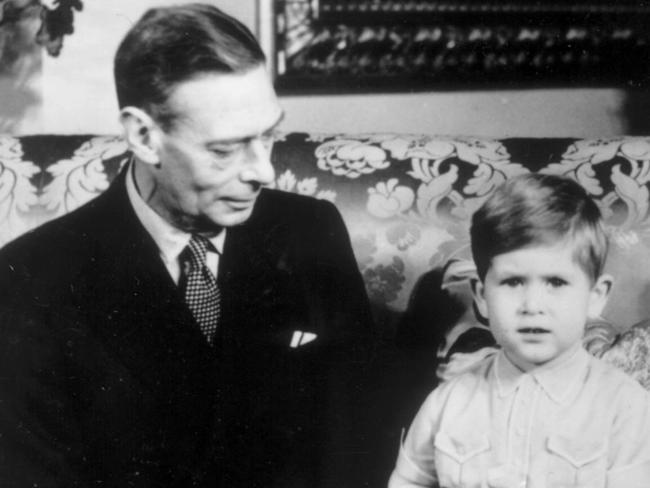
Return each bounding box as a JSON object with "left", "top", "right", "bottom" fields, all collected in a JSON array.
[{"left": 126, "top": 160, "right": 226, "bottom": 262}]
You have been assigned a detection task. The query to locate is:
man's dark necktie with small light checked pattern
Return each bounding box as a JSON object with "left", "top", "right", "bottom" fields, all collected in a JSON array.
[{"left": 180, "top": 234, "right": 221, "bottom": 344}]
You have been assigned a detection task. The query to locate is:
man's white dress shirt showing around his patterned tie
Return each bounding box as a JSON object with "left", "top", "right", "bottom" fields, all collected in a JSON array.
[{"left": 126, "top": 162, "right": 226, "bottom": 284}]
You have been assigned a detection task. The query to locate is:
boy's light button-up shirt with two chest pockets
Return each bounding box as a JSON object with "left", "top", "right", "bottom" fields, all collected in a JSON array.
[{"left": 389, "top": 348, "right": 650, "bottom": 488}]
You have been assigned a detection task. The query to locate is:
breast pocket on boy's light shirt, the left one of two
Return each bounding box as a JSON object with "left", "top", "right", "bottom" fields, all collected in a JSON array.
[{"left": 435, "top": 431, "right": 490, "bottom": 488}]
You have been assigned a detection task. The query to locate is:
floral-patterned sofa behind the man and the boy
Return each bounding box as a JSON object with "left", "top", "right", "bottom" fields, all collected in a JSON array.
[{"left": 0, "top": 133, "right": 650, "bottom": 480}]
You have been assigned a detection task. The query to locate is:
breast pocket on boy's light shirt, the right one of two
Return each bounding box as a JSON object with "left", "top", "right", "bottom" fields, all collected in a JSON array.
[{"left": 547, "top": 436, "right": 607, "bottom": 488}]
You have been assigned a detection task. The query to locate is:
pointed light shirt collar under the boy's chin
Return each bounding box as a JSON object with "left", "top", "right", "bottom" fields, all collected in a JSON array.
[{"left": 494, "top": 347, "right": 589, "bottom": 404}]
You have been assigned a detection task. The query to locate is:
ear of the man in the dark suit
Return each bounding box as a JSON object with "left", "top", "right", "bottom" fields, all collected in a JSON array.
[{"left": 120, "top": 107, "right": 160, "bottom": 165}]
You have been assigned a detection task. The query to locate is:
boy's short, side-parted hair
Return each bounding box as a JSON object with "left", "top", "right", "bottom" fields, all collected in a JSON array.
[{"left": 470, "top": 173, "right": 608, "bottom": 281}]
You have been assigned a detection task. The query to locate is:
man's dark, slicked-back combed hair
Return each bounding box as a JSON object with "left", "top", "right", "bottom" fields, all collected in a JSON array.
[{"left": 114, "top": 3, "right": 265, "bottom": 128}]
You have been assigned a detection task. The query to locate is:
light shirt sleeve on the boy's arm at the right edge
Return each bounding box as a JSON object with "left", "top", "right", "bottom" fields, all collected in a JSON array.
[{"left": 607, "top": 380, "right": 650, "bottom": 488}]
